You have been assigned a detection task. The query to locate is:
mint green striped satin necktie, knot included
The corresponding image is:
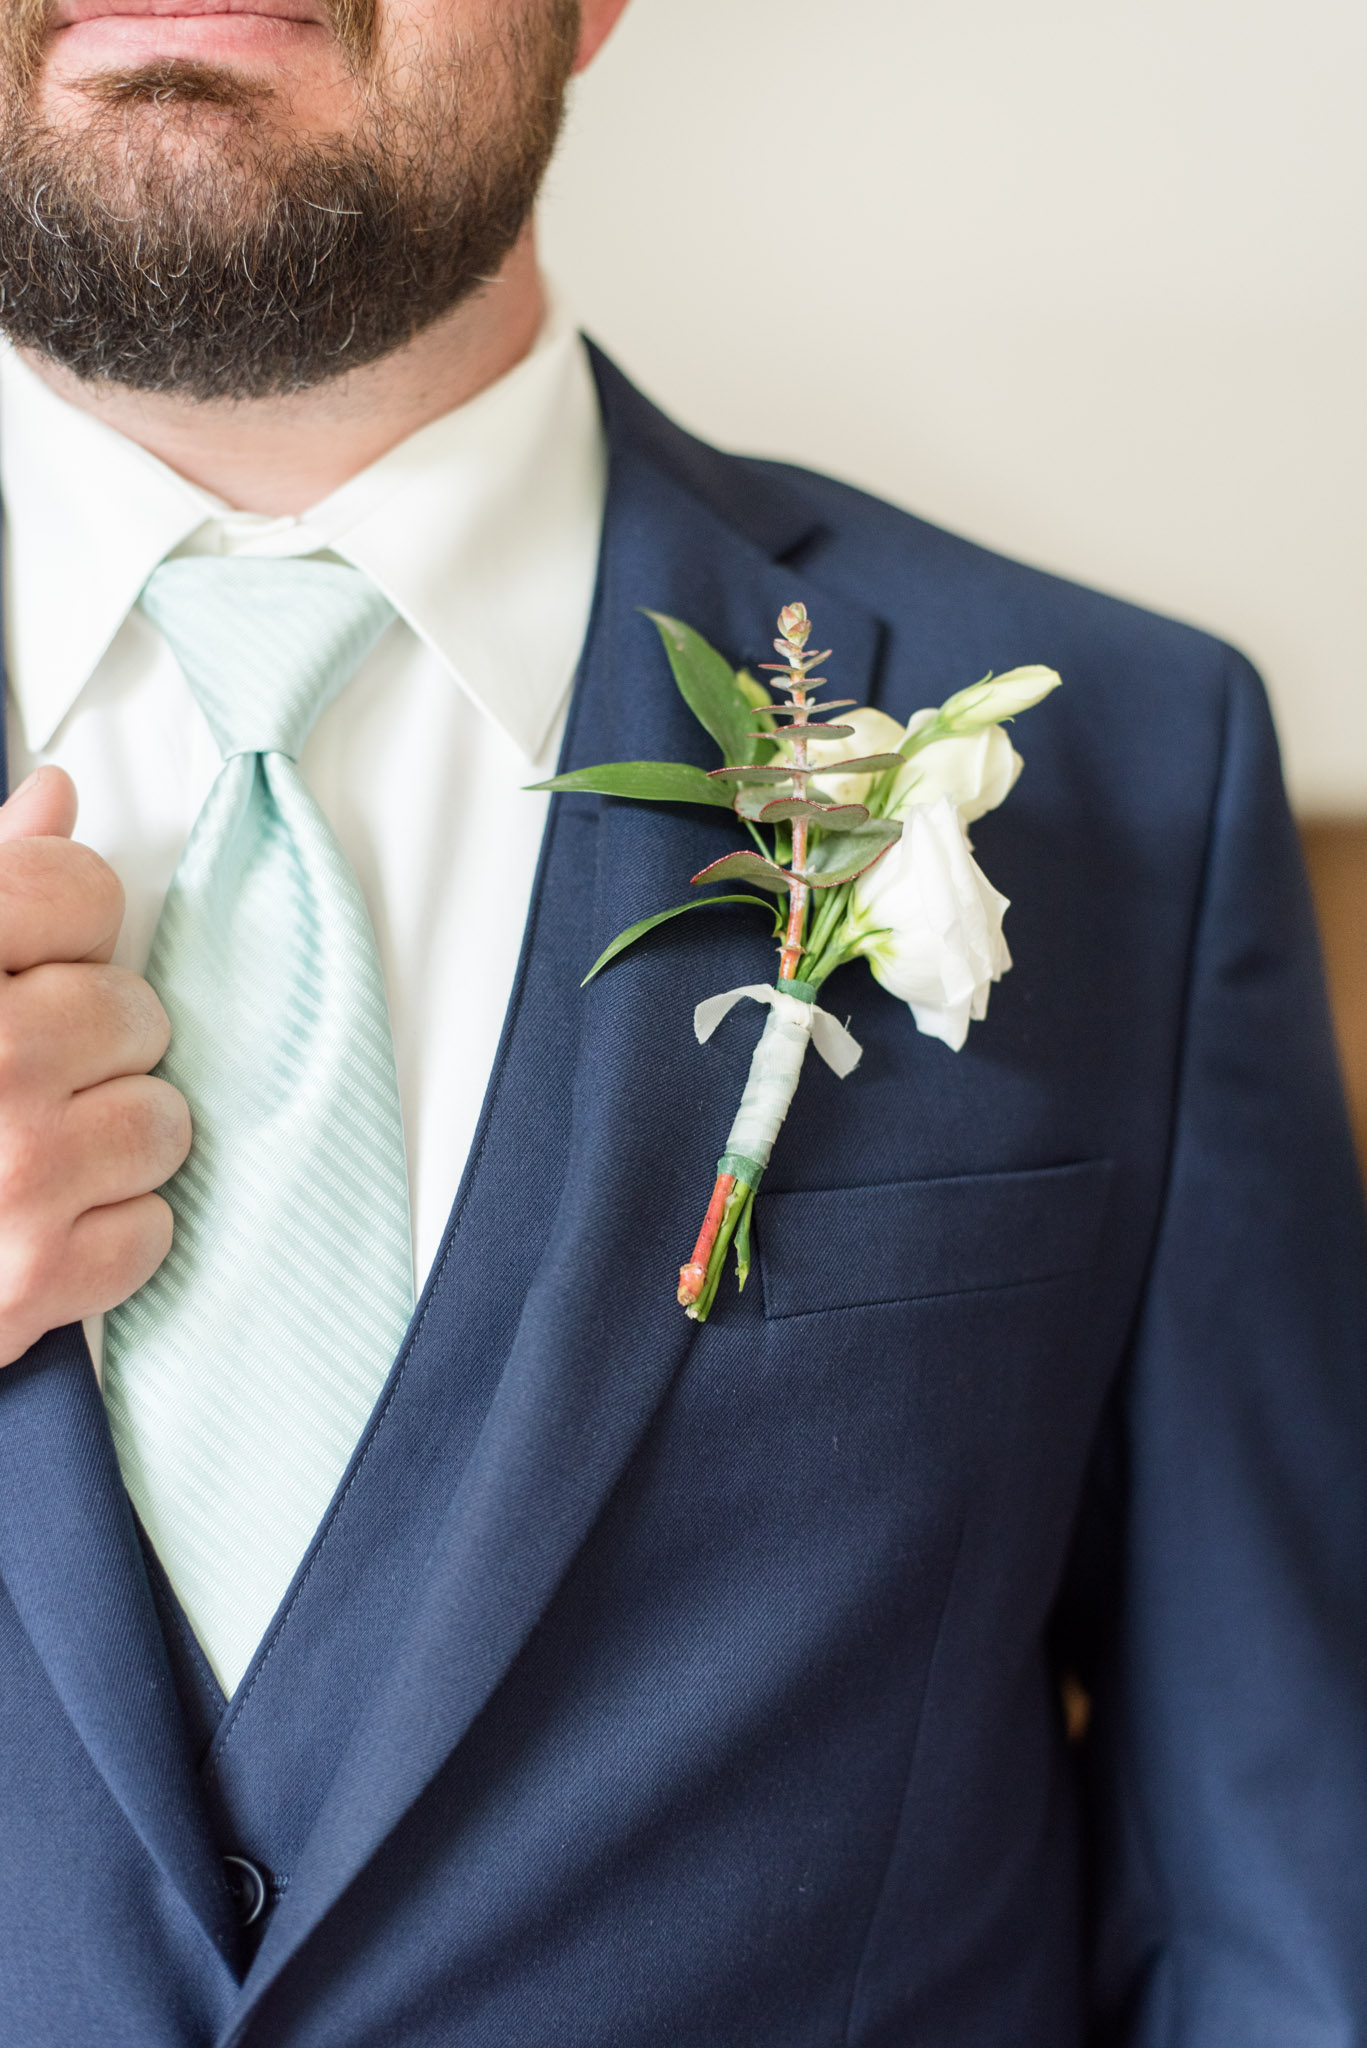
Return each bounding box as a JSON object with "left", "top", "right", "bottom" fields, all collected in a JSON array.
[{"left": 105, "top": 557, "right": 412, "bottom": 1692}]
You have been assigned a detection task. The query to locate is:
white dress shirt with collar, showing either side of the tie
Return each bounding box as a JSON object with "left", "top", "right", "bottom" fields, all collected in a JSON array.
[{"left": 0, "top": 296, "right": 607, "bottom": 1364}]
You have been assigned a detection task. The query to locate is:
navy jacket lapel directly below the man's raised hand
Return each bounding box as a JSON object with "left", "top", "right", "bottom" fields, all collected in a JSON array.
[{"left": 0, "top": 1329, "right": 238, "bottom": 1964}]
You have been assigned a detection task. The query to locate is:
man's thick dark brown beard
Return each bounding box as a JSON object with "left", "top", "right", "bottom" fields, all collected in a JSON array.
[{"left": 0, "top": 0, "right": 578, "bottom": 399}]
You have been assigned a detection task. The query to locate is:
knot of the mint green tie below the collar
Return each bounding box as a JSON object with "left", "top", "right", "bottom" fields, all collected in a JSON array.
[{"left": 139, "top": 555, "right": 393, "bottom": 760}]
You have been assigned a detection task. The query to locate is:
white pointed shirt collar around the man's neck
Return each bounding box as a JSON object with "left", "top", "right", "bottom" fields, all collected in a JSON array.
[{"left": 0, "top": 301, "right": 607, "bottom": 760}]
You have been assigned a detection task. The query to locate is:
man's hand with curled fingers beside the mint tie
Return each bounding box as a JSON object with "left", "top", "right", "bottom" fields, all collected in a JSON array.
[{"left": 0, "top": 768, "right": 191, "bottom": 1366}]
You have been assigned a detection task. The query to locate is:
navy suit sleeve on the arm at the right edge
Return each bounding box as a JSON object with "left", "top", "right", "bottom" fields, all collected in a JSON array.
[{"left": 1072, "top": 657, "right": 1367, "bottom": 2048}]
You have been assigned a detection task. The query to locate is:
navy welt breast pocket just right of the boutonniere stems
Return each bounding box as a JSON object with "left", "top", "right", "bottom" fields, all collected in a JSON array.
[{"left": 756, "top": 1159, "right": 1113, "bottom": 1321}]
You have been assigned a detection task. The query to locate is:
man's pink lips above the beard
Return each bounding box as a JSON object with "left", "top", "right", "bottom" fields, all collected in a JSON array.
[{"left": 46, "top": 0, "right": 332, "bottom": 80}]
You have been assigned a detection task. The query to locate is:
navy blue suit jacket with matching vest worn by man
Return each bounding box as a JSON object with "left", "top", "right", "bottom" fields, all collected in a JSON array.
[{"left": 0, "top": 362, "right": 1367, "bottom": 2048}]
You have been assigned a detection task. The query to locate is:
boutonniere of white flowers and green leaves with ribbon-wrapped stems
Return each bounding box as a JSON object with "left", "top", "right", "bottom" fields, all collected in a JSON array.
[{"left": 535, "top": 604, "right": 1060, "bottom": 1323}]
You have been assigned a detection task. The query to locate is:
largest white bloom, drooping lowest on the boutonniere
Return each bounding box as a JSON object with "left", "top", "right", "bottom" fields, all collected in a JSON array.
[{"left": 851, "top": 797, "right": 1010, "bottom": 1053}]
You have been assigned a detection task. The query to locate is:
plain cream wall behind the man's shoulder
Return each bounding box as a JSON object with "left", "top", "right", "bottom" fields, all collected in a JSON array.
[{"left": 545, "top": 0, "right": 1367, "bottom": 815}]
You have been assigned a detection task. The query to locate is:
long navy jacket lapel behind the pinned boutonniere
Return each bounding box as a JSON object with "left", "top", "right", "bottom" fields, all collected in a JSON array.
[{"left": 225, "top": 371, "right": 879, "bottom": 2048}]
